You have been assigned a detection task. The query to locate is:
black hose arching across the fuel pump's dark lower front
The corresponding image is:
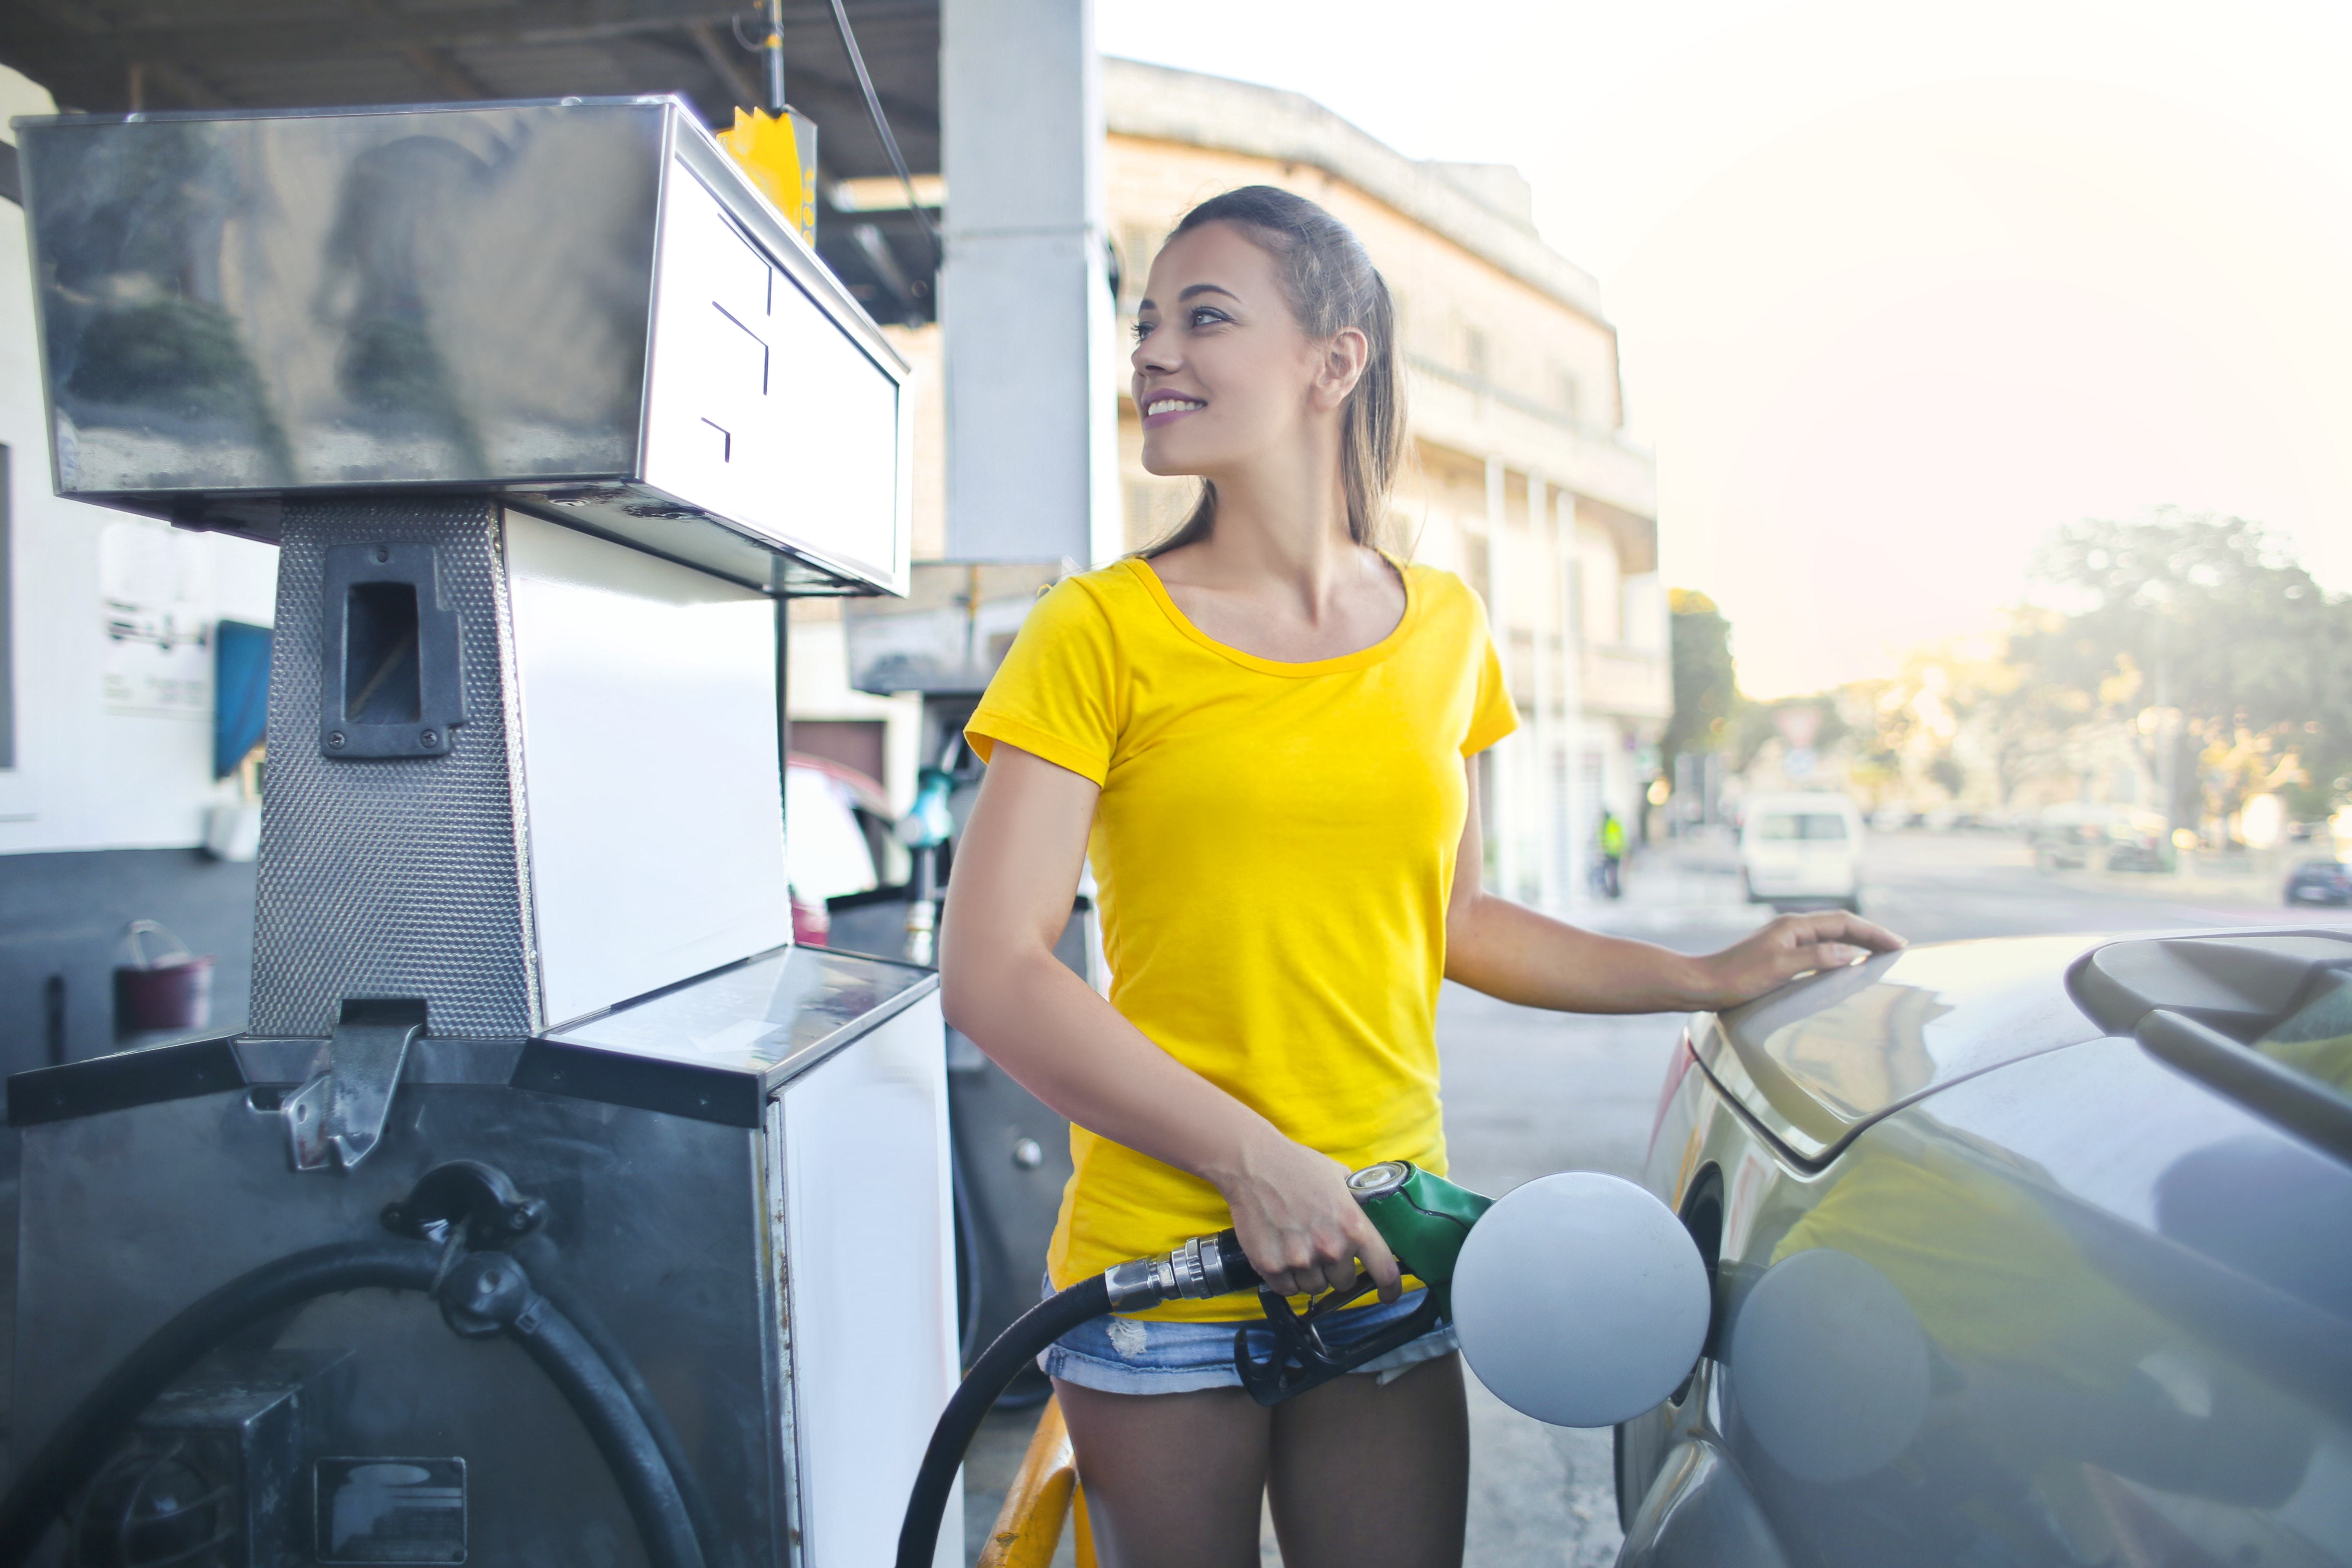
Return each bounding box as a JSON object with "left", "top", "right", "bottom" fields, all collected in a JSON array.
[{"left": 0, "top": 1241, "right": 703, "bottom": 1568}]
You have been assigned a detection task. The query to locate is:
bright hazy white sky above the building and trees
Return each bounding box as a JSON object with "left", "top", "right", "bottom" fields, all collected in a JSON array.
[{"left": 1096, "top": 0, "right": 2352, "bottom": 696}]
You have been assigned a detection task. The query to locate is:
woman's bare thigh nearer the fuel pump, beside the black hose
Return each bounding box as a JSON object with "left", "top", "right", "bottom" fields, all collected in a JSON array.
[{"left": 1054, "top": 1378, "right": 1270, "bottom": 1568}]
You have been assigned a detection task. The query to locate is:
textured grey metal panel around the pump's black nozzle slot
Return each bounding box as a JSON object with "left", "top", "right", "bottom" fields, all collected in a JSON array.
[{"left": 252, "top": 499, "right": 541, "bottom": 1037}]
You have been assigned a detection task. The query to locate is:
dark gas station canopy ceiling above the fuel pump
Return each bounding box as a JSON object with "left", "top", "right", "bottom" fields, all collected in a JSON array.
[{"left": 0, "top": 0, "right": 941, "bottom": 322}]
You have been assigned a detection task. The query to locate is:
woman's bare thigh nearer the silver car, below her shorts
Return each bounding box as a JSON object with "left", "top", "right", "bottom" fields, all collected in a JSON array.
[{"left": 1268, "top": 1354, "right": 1470, "bottom": 1568}]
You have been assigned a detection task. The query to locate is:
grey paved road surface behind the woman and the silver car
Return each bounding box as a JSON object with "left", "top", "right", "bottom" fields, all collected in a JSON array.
[{"left": 964, "top": 830, "right": 2343, "bottom": 1568}]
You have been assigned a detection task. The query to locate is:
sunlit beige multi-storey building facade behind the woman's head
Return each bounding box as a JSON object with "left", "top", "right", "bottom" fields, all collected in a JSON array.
[{"left": 793, "top": 61, "right": 1670, "bottom": 907}]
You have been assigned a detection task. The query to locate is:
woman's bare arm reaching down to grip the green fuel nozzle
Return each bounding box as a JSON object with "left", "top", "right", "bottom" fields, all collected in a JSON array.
[{"left": 938, "top": 740, "right": 1397, "bottom": 1300}]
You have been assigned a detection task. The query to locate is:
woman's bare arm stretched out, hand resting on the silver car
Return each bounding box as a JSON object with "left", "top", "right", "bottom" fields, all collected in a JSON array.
[{"left": 1446, "top": 764, "right": 1903, "bottom": 1013}]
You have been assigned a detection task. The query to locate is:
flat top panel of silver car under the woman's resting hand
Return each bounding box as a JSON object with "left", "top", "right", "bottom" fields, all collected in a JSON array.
[{"left": 1691, "top": 933, "right": 2114, "bottom": 1161}]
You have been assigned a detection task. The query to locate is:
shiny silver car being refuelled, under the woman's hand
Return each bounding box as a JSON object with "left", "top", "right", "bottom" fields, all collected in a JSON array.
[{"left": 1616, "top": 924, "right": 2352, "bottom": 1568}]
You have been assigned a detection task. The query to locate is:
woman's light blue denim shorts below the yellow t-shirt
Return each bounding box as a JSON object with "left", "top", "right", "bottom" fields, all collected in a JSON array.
[{"left": 1037, "top": 1281, "right": 1458, "bottom": 1394}]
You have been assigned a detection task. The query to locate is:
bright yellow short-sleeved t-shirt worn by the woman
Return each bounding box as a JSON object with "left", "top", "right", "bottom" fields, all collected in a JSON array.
[{"left": 964, "top": 559, "right": 1517, "bottom": 1321}]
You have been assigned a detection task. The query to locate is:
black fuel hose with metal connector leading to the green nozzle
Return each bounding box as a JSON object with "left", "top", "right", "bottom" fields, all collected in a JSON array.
[{"left": 898, "top": 1229, "right": 1258, "bottom": 1568}]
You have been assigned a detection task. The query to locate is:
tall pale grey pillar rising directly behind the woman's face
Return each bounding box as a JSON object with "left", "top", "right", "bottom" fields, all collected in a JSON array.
[{"left": 938, "top": 0, "right": 1120, "bottom": 564}]
